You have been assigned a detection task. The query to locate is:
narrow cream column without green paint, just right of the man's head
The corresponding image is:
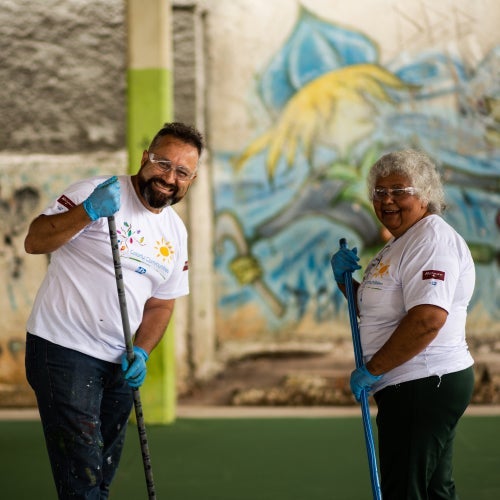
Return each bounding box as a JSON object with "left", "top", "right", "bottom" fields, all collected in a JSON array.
[{"left": 172, "top": 0, "right": 218, "bottom": 391}]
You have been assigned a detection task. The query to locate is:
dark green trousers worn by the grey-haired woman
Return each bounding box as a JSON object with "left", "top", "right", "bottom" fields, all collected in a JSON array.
[{"left": 375, "top": 367, "right": 474, "bottom": 500}]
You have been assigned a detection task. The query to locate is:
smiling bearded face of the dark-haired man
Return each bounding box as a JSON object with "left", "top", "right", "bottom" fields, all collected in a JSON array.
[{"left": 132, "top": 135, "right": 199, "bottom": 213}]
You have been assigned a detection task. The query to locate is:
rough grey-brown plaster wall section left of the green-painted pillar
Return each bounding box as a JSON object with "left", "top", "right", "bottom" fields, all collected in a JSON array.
[{"left": 0, "top": 0, "right": 126, "bottom": 154}]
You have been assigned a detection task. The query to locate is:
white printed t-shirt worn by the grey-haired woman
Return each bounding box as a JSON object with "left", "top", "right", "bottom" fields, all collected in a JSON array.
[{"left": 357, "top": 215, "right": 475, "bottom": 392}]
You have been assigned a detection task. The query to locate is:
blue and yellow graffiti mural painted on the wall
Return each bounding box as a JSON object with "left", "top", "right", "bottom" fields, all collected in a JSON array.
[{"left": 214, "top": 7, "right": 500, "bottom": 339}]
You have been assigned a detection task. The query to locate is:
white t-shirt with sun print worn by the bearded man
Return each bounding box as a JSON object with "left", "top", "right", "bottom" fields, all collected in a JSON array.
[{"left": 27, "top": 176, "right": 189, "bottom": 363}]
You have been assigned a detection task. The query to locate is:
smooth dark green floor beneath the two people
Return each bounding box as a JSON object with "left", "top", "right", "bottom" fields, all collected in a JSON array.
[{"left": 0, "top": 417, "right": 500, "bottom": 500}]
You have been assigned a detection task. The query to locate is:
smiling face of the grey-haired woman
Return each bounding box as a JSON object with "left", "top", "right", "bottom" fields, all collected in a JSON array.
[{"left": 373, "top": 174, "right": 429, "bottom": 238}]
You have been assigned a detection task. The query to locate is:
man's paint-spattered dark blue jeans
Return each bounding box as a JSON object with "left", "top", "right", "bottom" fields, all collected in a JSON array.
[{"left": 26, "top": 333, "right": 133, "bottom": 500}]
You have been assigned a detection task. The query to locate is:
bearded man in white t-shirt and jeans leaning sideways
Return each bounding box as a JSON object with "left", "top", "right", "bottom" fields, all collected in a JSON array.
[{"left": 25, "top": 123, "right": 203, "bottom": 499}]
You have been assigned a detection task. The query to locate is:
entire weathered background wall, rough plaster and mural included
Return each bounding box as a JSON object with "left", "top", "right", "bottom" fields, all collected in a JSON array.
[{"left": 0, "top": 0, "right": 500, "bottom": 400}]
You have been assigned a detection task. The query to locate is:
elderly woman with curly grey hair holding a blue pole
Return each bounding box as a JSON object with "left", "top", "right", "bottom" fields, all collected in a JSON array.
[{"left": 332, "top": 150, "right": 475, "bottom": 500}]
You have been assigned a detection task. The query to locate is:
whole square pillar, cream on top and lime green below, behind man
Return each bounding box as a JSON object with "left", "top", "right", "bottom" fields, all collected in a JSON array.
[{"left": 127, "top": 0, "right": 177, "bottom": 423}]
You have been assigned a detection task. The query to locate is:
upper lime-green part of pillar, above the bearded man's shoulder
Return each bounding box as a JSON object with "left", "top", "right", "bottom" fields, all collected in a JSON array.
[{"left": 127, "top": 68, "right": 173, "bottom": 173}]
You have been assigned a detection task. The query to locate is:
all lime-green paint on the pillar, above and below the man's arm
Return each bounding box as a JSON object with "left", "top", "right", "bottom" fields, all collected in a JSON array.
[{"left": 127, "top": 69, "right": 177, "bottom": 424}]
